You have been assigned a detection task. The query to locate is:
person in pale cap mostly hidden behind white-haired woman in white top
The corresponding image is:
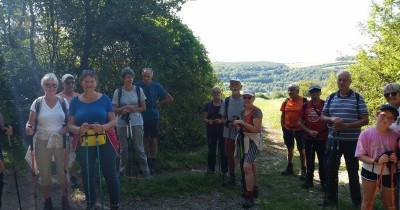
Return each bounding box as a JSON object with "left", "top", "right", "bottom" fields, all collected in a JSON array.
[{"left": 57, "top": 74, "right": 79, "bottom": 188}]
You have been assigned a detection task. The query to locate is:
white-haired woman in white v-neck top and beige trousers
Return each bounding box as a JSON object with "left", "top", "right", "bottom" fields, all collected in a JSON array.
[{"left": 25, "top": 73, "right": 70, "bottom": 210}]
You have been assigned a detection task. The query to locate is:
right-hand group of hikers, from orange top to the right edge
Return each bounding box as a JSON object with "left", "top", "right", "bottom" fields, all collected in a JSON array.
[{"left": 280, "top": 71, "right": 400, "bottom": 210}]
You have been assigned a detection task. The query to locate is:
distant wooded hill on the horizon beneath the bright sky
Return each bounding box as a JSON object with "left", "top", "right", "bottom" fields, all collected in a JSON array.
[{"left": 212, "top": 59, "right": 355, "bottom": 93}]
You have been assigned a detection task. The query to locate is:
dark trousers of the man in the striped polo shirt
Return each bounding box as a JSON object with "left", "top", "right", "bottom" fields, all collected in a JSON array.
[{"left": 326, "top": 137, "right": 361, "bottom": 204}]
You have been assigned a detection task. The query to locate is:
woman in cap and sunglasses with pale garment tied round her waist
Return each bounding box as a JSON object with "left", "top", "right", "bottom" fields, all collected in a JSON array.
[{"left": 233, "top": 90, "right": 263, "bottom": 208}]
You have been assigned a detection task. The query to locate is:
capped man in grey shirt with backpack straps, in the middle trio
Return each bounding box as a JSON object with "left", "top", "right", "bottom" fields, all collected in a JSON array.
[{"left": 219, "top": 78, "right": 244, "bottom": 186}]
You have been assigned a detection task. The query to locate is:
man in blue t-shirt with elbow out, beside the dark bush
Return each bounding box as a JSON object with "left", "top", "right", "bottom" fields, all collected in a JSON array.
[{"left": 135, "top": 68, "right": 173, "bottom": 173}]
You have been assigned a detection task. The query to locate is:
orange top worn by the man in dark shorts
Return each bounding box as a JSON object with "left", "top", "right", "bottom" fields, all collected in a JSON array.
[{"left": 281, "top": 97, "right": 303, "bottom": 130}]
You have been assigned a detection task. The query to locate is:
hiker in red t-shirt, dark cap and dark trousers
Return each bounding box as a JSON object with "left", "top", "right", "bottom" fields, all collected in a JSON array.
[{"left": 299, "top": 85, "right": 328, "bottom": 190}]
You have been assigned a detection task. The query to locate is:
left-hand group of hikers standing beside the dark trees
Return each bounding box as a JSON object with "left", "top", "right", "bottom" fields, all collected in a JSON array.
[{"left": 0, "top": 68, "right": 173, "bottom": 210}]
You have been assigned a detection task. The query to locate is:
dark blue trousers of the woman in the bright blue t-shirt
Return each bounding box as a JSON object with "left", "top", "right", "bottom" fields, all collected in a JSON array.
[{"left": 76, "top": 141, "right": 120, "bottom": 205}]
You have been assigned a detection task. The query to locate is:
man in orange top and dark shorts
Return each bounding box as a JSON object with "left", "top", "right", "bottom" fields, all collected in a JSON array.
[{"left": 280, "top": 83, "right": 307, "bottom": 179}]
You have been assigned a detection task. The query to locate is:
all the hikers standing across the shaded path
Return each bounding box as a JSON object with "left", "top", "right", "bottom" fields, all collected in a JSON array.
[{"left": 0, "top": 68, "right": 400, "bottom": 210}]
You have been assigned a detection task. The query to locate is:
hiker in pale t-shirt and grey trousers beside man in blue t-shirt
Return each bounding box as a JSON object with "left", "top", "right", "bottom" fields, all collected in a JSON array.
[{"left": 112, "top": 68, "right": 150, "bottom": 178}]
